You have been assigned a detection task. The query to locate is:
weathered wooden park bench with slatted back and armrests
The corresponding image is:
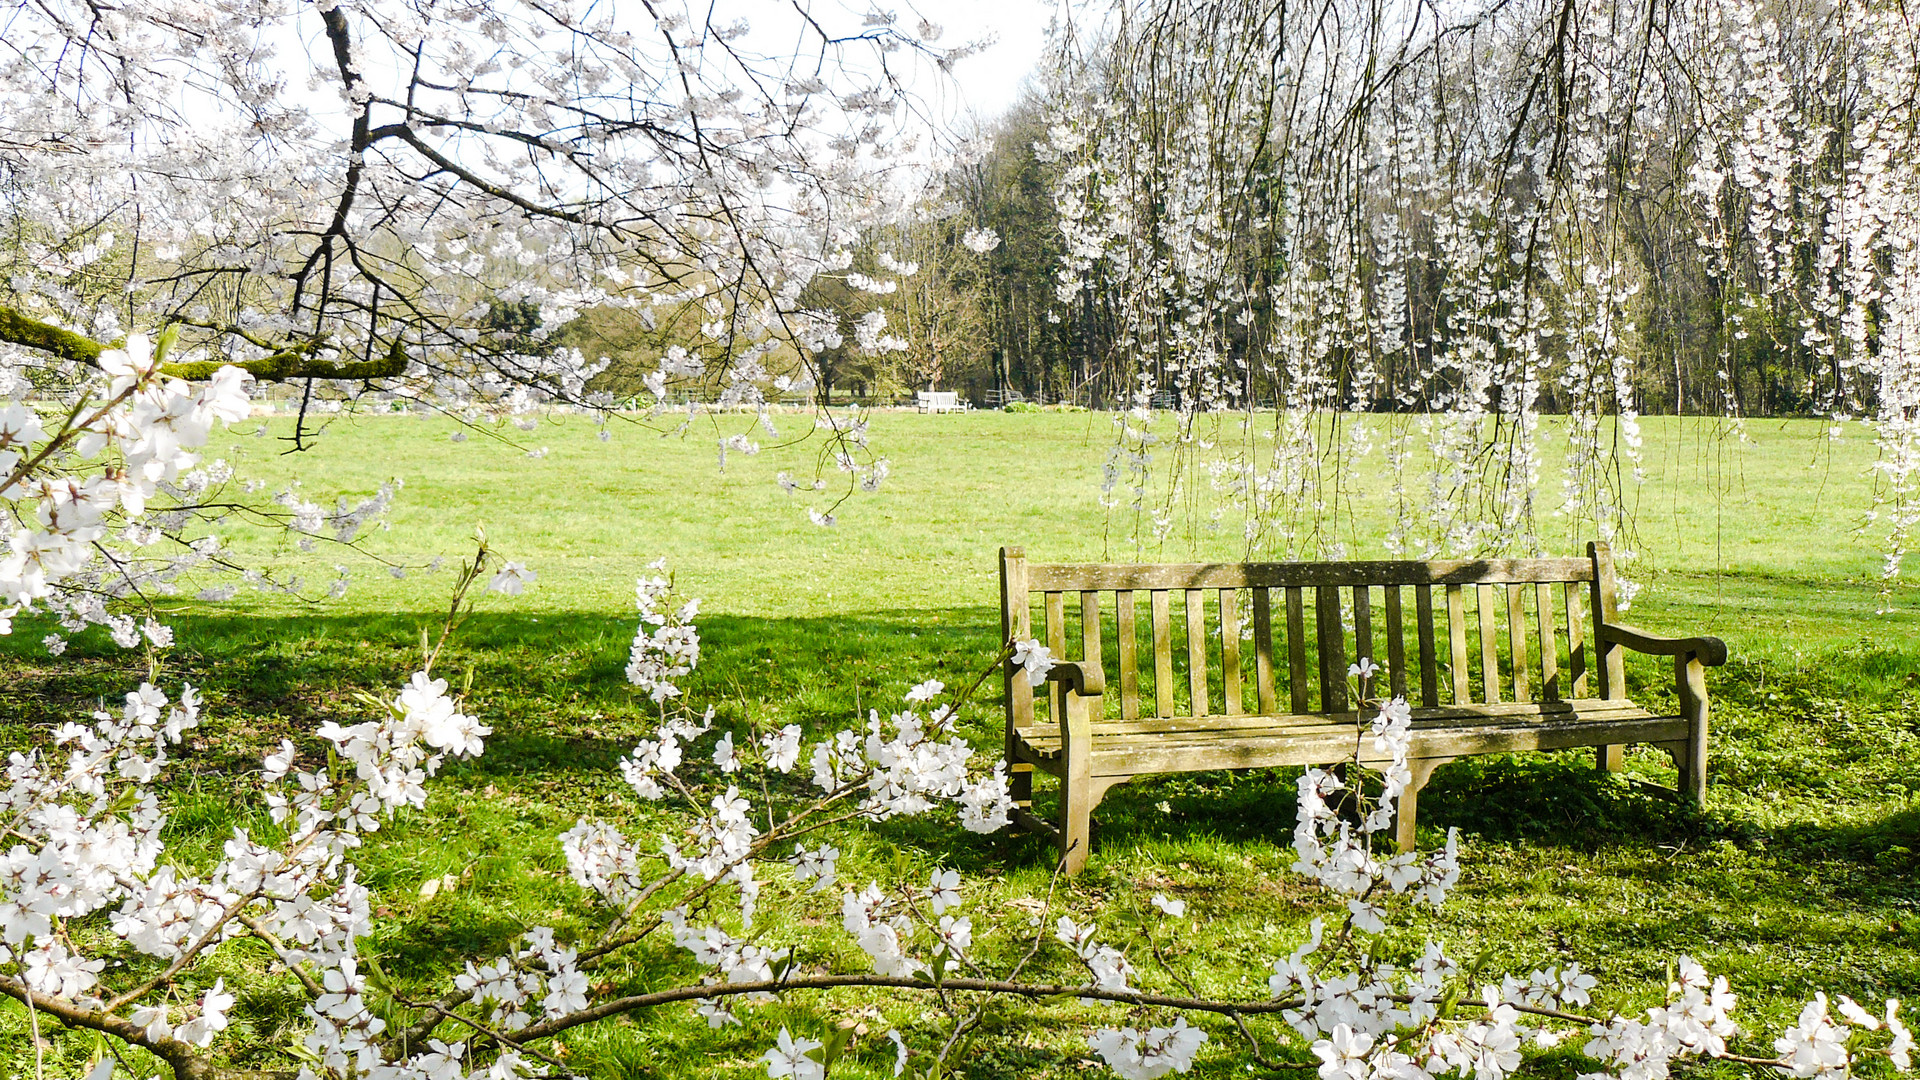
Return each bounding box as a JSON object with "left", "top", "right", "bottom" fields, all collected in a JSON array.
[{"left": 1000, "top": 544, "right": 1726, "bottom": 874}]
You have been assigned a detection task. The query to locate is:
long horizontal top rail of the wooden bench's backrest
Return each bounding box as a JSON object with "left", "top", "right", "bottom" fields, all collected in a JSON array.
[{"left": 1027, "top": 559, "right": 1594, "bottom": 592}]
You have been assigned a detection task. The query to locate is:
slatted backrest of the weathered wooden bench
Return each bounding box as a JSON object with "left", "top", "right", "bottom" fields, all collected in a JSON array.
[{"left": 1000, "top": 544, "right": 1624, "bottom": 726}]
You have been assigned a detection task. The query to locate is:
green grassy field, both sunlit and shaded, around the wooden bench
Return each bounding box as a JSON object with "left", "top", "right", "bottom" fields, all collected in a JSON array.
[{"left": 0, "top": 413, "right": 1920, "bottom": 1078}]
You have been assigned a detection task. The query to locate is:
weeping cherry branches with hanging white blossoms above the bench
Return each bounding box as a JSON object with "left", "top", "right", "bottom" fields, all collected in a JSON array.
[{"left": 1039, "top": 0, "right": 1920, "bottom": 577}]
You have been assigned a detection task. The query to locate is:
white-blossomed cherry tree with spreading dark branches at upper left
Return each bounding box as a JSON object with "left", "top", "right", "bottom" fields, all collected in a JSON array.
[{"left": 0, "top": 0, "right": 972, "bottom": 648}]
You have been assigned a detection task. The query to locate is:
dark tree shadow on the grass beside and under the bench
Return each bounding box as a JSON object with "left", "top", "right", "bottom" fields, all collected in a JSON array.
[{"left": 0, "top": 607, "right": 1920, "bottom": 872}]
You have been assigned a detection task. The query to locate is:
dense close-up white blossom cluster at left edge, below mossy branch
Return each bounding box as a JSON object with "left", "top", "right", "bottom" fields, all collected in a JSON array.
[{"left": 0, "top": 329, "right": 399, "bottom": 655}]
